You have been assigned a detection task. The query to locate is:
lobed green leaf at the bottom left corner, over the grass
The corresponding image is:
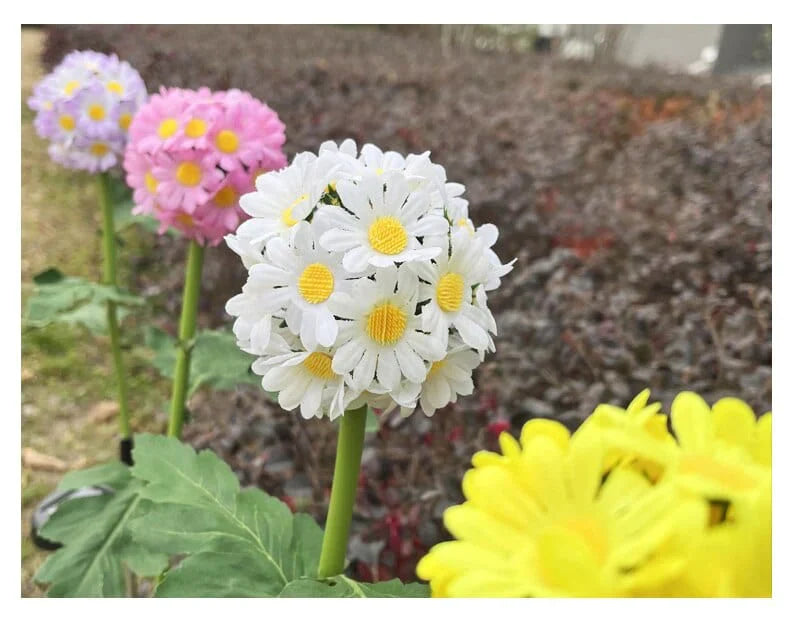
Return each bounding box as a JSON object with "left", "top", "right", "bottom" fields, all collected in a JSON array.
[{"left": 35, "top": 470, "right": 167, "bottom": 597}]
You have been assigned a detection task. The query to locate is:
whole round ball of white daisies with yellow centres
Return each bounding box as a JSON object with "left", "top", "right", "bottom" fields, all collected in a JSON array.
[{"left": 225, "top": 140, "right": 513, "bottom": 419}]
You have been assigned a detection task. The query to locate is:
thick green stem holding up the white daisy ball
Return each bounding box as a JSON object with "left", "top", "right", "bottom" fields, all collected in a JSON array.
[{"left": 318, "top": 406, "right": 367, "bottom": 578}]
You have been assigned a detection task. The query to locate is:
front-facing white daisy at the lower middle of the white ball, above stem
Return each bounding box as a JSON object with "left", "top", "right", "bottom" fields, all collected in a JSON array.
[{"left": 332, "top": 267, "right": 445, "bottom": 391}]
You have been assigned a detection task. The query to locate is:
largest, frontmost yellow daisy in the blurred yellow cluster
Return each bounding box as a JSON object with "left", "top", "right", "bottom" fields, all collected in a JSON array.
[{"left": 417, "top": 420, "right": 706, "bottom": 597}]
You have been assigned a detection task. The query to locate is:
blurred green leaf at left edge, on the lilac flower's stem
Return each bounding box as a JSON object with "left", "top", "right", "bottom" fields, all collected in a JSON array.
[{"left": 25, "top": 269, "right": 144, "bottom": 332}]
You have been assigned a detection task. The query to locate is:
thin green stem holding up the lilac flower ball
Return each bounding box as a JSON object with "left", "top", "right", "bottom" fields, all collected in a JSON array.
[{"left": 97, "top": 172, "right": 132, "bottom": 438}]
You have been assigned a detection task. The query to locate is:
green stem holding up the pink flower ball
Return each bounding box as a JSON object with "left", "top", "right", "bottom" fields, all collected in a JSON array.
[{"left": 167, "top": 241, "right": 203, "bottom": 438}]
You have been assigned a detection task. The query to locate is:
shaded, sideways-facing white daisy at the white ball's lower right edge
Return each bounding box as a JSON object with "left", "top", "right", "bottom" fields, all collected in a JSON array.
[{"left": 401, "top": 338, "right": 481, "bottom": 417}]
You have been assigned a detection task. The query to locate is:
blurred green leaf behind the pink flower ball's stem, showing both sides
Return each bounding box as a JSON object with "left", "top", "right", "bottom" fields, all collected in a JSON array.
[{"left": 146, "top": 328, "right": 260, "bottom": 397}]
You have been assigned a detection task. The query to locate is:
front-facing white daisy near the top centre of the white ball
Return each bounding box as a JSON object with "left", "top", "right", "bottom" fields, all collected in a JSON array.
[{"left": 315, "top": 171, "right": 448, "bottom": 273}]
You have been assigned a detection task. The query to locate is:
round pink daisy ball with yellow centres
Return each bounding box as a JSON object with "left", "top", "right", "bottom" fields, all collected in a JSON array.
[{"left": 123, "top": 88, "right": 286, "bottom": 245}]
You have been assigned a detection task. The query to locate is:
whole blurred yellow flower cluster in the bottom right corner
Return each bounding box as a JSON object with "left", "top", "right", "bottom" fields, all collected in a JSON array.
[{"left": 417, "top": 390, "right": 771, "bottom": 597}]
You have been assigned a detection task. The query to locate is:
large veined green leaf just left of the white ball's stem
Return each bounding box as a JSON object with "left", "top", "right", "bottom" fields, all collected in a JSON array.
[{"left": 131, "top": 435, "right": 322, "bottom": 597}]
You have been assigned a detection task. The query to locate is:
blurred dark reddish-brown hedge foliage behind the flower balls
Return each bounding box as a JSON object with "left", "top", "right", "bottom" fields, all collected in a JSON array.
[{"left": 40, "top": 26, "right": 772, "bottom": 580}]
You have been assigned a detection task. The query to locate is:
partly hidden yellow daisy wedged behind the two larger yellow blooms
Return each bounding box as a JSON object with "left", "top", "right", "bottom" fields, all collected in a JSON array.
[{"left": 577, "top": 389, "right": 674, "bottom": 482}]
